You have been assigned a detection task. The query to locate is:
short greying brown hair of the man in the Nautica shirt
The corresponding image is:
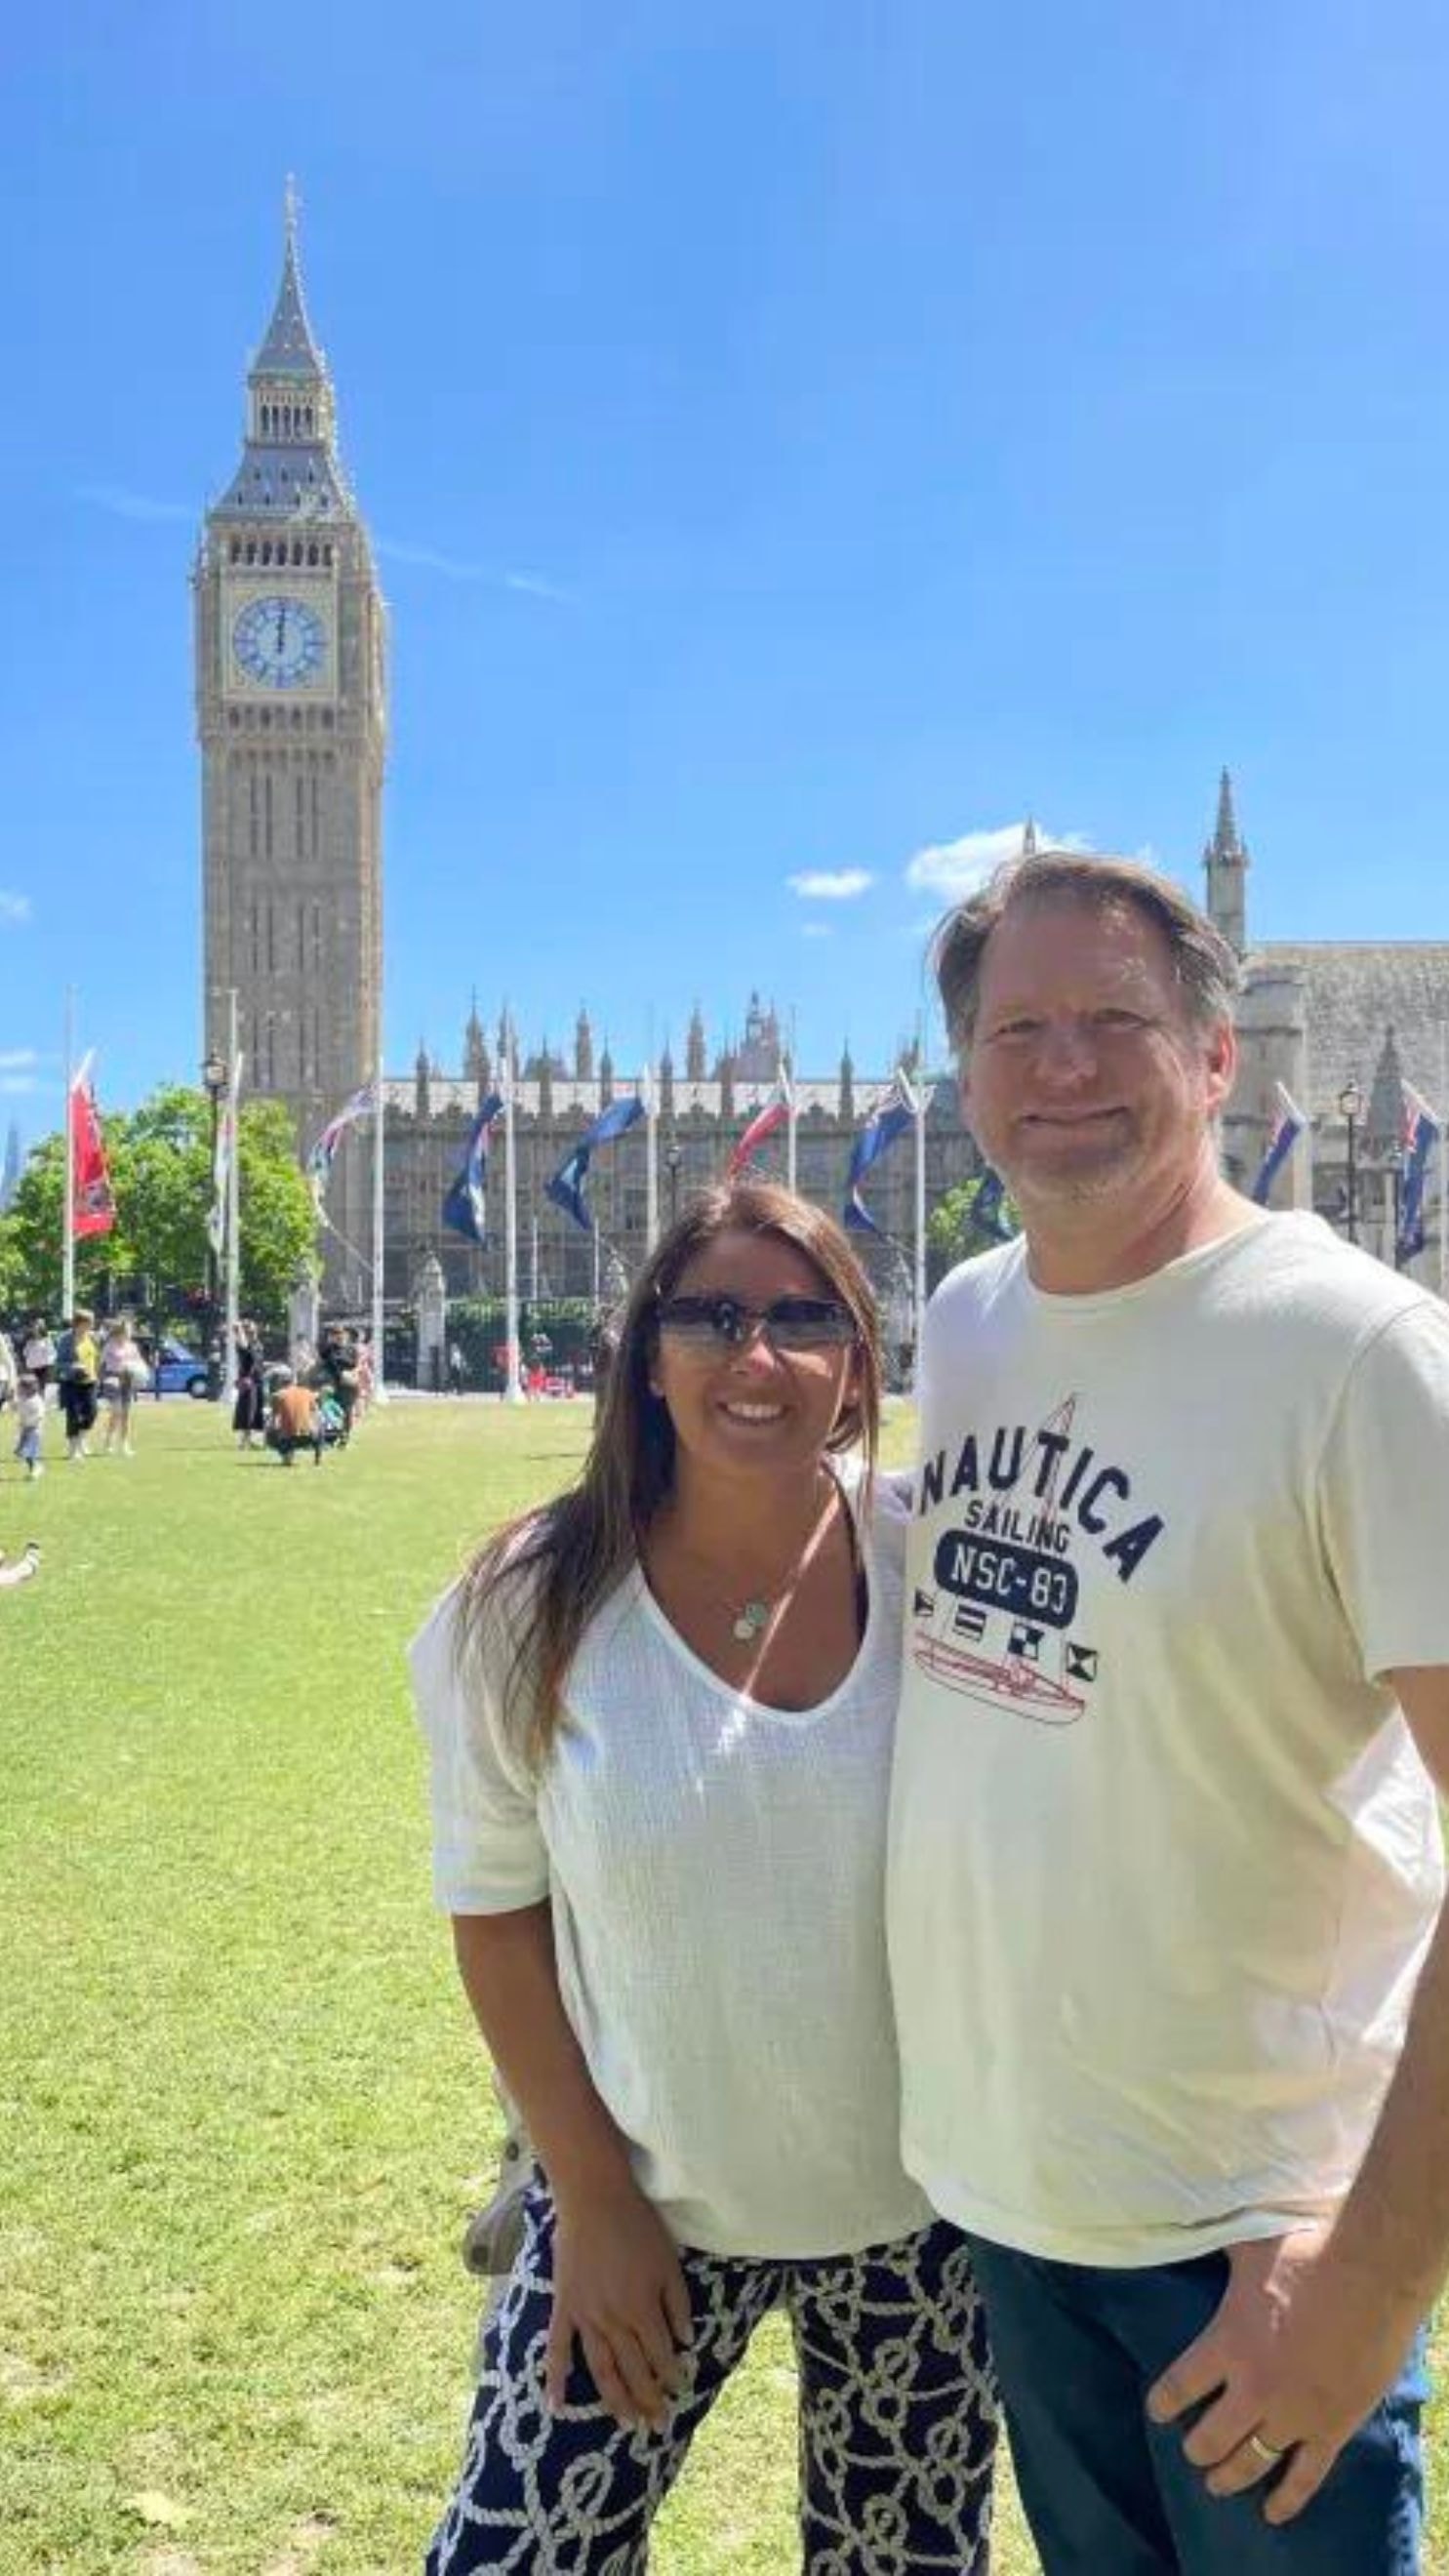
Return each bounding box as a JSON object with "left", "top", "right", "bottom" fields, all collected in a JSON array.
[{"left": 931, "top": 850, "right": 1240, "bottom": 1051}]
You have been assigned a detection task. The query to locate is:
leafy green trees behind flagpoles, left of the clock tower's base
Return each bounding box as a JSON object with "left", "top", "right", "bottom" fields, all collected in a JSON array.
[{"left": 0, "top": 1082, "right": 317, "bottom": 1324}]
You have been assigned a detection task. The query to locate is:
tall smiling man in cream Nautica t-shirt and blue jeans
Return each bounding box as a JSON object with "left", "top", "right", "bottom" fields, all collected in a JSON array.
[{"left": 890, "top": 853, "right": 1449, "bottom": 2576}]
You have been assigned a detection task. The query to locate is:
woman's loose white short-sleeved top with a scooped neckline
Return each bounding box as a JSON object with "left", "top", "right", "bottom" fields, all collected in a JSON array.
[{"left": 413, "top": 1489, "right": 931, "bottom": 2257}]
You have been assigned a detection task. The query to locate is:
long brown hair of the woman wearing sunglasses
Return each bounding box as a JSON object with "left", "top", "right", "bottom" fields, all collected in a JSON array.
[{"left": 459, "top": 1180, "right": 882, "bottom": 1767}]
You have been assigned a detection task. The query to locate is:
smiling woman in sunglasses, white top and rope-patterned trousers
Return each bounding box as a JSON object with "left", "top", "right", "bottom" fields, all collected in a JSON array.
[{"left": 413, "top": 1183, "right": 995, "bottom": 2576}]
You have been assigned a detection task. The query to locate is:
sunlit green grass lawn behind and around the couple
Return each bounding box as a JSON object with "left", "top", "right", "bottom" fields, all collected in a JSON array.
[{"left": 0, "top": 1399, "right": 1449, "bottom": 2576}]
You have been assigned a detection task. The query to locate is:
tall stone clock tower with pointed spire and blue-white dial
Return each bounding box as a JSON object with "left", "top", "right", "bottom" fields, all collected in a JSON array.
[{"left": 193, "top": 185, "right": 386, "bottom": 1267}]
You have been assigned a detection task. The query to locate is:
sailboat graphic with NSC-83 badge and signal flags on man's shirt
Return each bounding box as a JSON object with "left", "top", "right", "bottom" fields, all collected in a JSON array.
[{"left": 910, "top": 1396, "right": 1099, "bottom": 1726}]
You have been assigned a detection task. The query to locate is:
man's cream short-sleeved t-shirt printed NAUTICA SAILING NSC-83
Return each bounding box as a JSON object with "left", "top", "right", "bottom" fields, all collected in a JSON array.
[{"left": 890, "top": 1216, "right": 1449, "bottom": 2265}]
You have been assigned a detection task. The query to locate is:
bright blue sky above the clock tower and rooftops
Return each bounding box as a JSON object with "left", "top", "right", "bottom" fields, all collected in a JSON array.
[{"left": 0, "top": 0, "right": 1449, "bottom": 1134}]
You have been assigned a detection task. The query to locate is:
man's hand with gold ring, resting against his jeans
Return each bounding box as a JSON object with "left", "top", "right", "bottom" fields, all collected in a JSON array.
[{"left": 1147, "top": 2226, "right": 1418, "bottom": 2522}]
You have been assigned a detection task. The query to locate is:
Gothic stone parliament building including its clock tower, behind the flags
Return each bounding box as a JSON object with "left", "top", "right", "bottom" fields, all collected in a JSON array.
[{"left": 193, "top": 196, "right": 1449, "bottom": 1304}]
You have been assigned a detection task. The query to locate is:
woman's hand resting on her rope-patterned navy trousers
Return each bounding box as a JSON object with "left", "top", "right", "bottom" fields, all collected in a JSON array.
[{"left": 546, "top": 2179, "right": 694, "bottom": 2430}]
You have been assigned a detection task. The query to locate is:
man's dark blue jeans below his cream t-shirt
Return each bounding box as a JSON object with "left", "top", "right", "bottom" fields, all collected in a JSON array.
[{"left": 972, "top": 2238, "right": 1429, "bottom": 2576}]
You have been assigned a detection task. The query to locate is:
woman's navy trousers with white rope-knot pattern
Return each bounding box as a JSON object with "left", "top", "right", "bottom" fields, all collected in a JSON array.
[{"left": 428, "top": 2190, "right": 995, "bottom": 2576}]
